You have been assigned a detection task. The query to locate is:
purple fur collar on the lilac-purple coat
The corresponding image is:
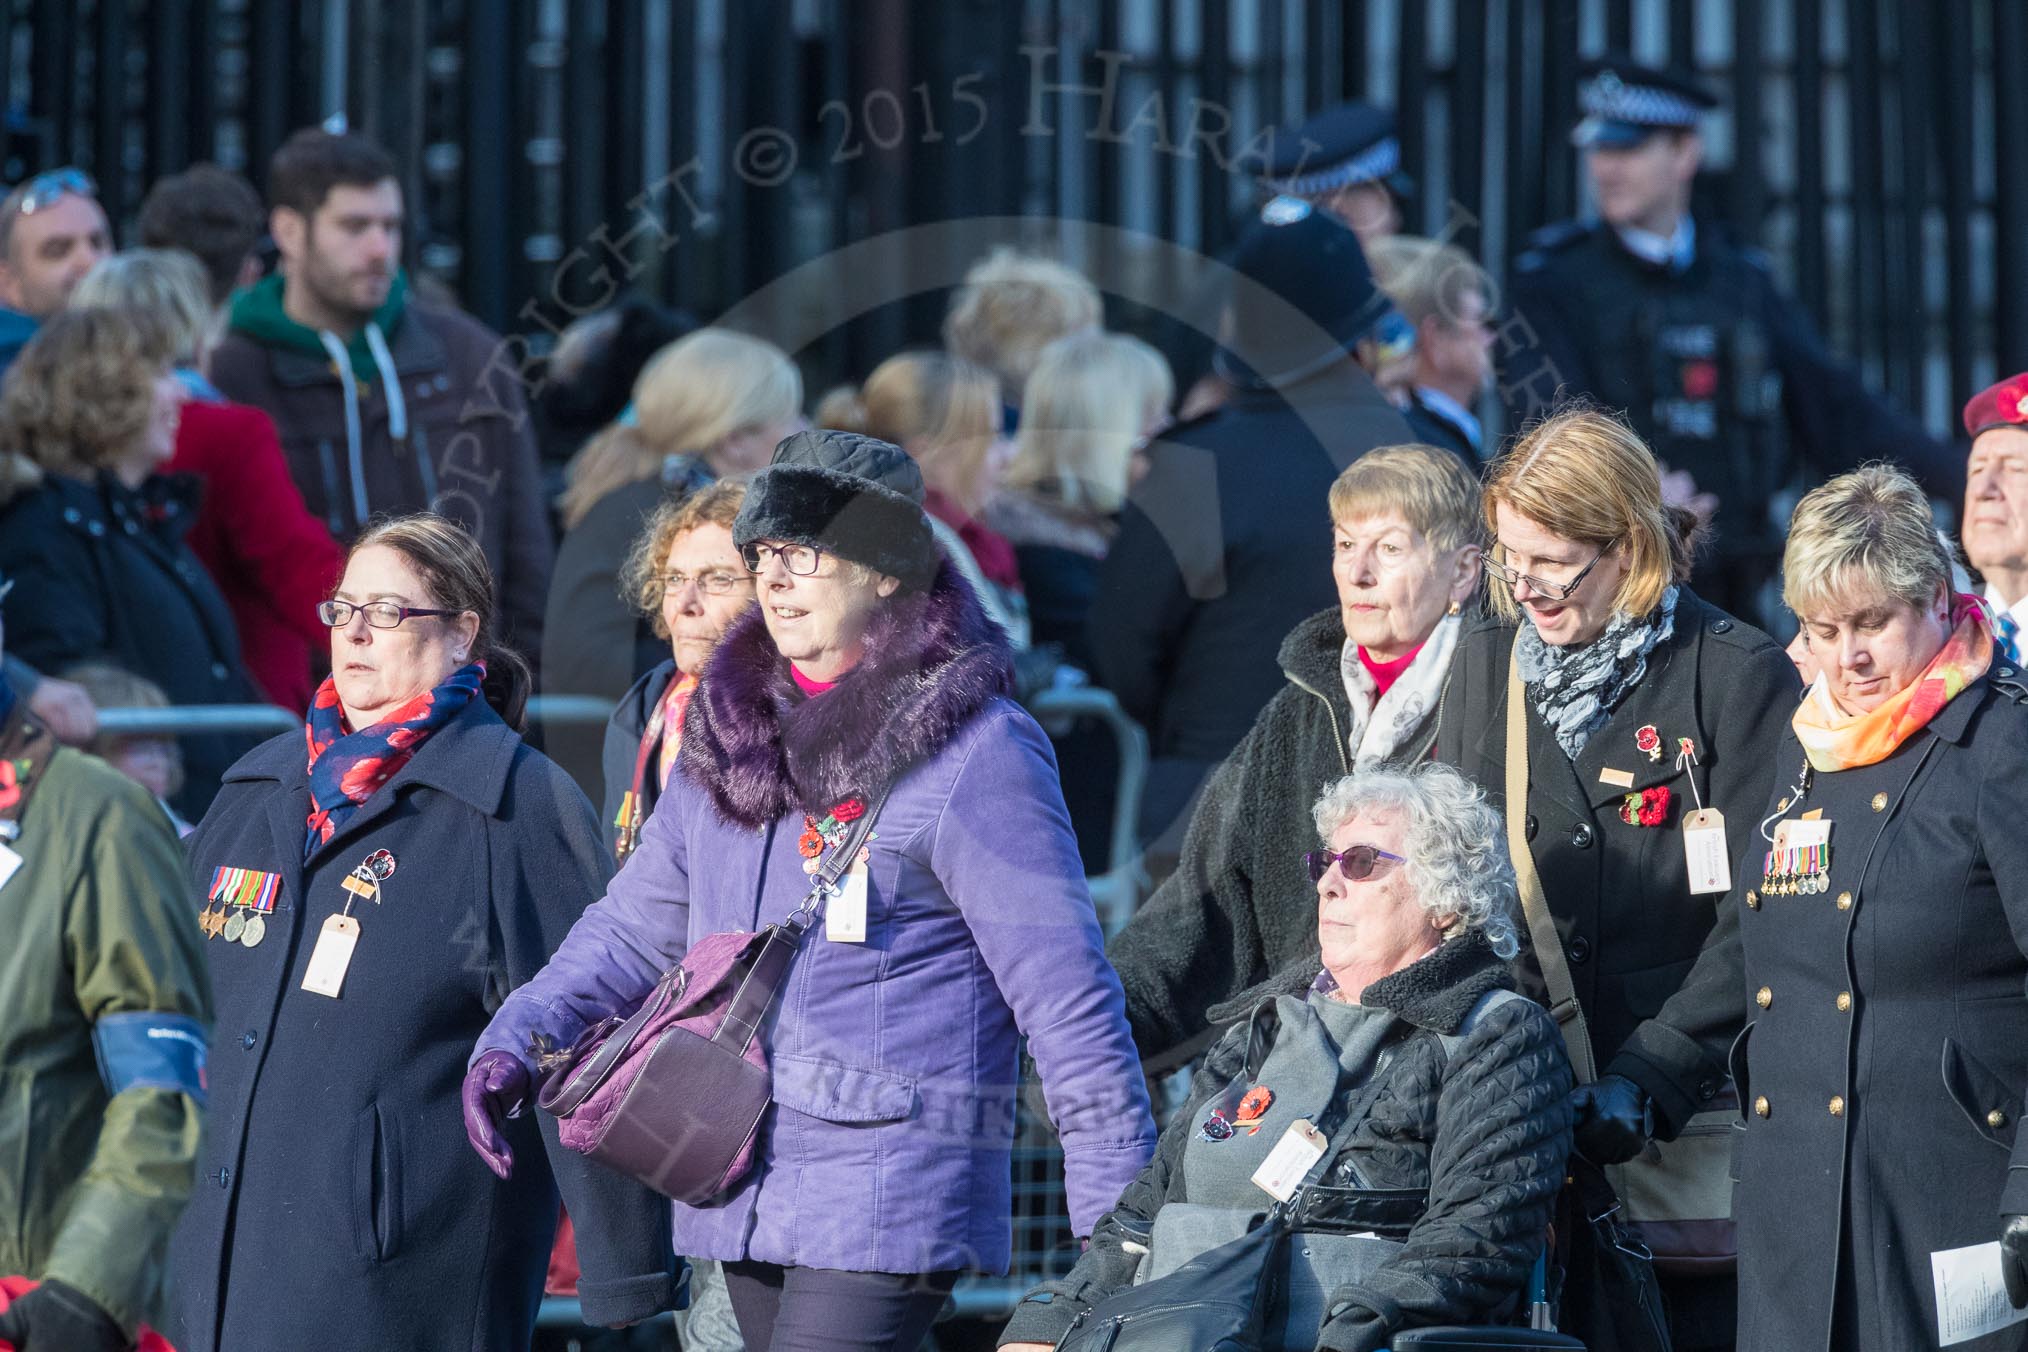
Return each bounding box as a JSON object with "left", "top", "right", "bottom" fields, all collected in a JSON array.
[{"left": 679, "top": 564, "right": 1014, "bottom": 827}]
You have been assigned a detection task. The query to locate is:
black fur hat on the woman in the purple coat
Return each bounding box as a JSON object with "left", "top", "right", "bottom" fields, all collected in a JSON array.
[{"left": 732, "top": 430, "right": 943, "bottom": 592}]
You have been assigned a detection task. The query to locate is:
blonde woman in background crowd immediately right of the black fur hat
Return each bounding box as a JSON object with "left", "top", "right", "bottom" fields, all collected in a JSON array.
[{"left": 840, "top": 351, "right": 1028, "bottom": 649}]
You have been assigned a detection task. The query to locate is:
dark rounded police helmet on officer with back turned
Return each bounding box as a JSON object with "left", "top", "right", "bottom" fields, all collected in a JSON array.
[{"left": 1213, "top": 197, "right": 1391, "bottom": 389}]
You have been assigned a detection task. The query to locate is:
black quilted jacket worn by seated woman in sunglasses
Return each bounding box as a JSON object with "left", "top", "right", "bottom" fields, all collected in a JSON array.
[{"left": 1000, "top": 934, "right": 1572, "bottom": 1352}]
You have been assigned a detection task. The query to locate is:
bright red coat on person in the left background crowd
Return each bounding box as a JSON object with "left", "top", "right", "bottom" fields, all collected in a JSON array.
[{"left": 168, "top": 399, "right": 345, "bottom": 711}]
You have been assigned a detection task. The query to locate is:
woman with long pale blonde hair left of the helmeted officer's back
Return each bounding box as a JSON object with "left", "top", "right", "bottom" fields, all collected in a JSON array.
[{"left": 988, "top": 332, "right": 1176, "bottom": 665}]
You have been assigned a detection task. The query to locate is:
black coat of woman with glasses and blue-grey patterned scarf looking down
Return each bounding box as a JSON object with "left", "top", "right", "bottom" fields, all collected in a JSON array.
[{"left": 1436, "top": 588, "right": 1801, "bottom": 1135}]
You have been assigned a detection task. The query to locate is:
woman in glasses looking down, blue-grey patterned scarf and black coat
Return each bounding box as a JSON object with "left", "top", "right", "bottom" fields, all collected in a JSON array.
[{"left": 1436, "top": 407, "right": 1799, "bottom": 1350}]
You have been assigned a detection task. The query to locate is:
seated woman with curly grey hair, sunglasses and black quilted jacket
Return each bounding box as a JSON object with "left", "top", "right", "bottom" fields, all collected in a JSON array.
[{"left": 1000, "top": 762, "right": 1572, "bottom": 1352}]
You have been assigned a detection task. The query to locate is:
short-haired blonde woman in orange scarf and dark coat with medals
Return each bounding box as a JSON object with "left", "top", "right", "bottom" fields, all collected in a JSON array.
[{"left": 1622, "top": 464, "right": 2028, "bottom": 1352}]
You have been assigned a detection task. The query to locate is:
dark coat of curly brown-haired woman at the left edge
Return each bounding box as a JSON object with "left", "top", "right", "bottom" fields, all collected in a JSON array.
[{"left": 0, "top": 474, "right": 266, "bottom": 821}]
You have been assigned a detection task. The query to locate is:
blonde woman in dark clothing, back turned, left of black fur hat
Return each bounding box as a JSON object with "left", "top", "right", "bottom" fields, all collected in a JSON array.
[{"left": 541, "top": 328, "right": 803, "bottom": 797}]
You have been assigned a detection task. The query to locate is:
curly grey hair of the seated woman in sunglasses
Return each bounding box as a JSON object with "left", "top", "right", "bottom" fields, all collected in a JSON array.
[{"left": 1312, "top": 762, "right": 1521, "bottom": 959}]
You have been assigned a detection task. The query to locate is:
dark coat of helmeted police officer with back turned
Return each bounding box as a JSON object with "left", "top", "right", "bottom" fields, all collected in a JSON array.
[{"left": 1085, "top": 361, "right": 1414, "bottom": 839}]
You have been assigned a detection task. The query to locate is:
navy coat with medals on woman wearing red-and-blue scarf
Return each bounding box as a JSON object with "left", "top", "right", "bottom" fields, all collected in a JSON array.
[{"left": 166, "top": 699, "right": 675, "bottom": 1352}]
